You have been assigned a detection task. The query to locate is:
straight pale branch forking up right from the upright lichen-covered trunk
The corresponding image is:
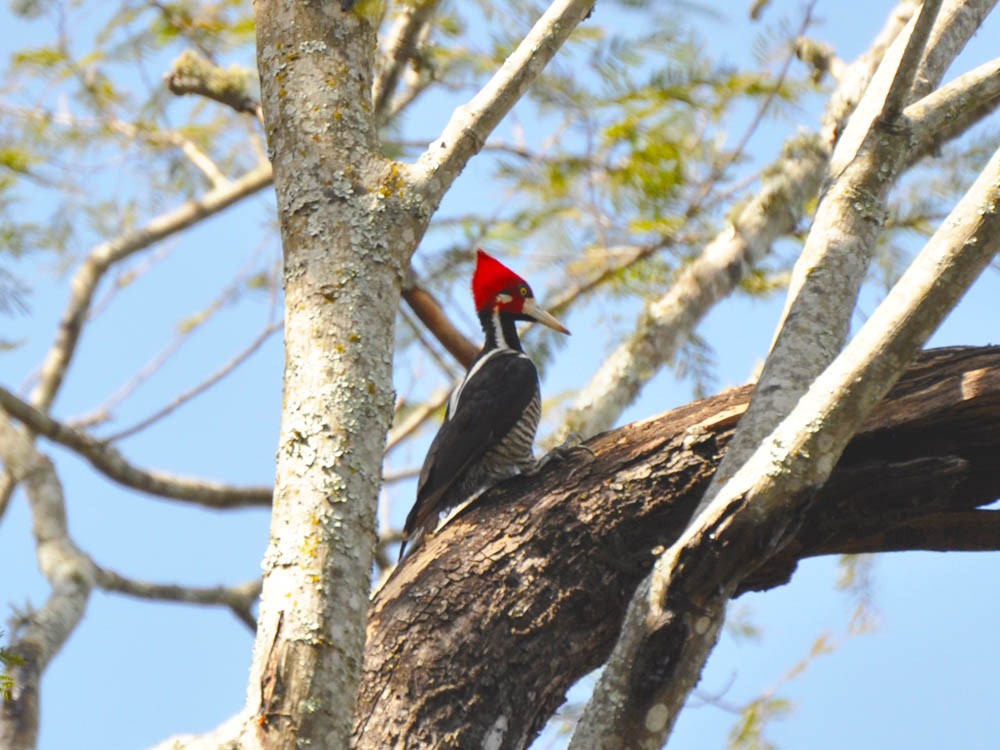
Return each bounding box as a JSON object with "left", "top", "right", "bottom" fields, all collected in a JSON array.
[{"left": 411, "top": 0, "right": 594, "bottom": 210}]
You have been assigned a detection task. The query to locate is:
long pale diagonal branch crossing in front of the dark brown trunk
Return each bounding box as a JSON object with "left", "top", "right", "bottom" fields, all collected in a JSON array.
[{"left": 570, "top": 145, "right": 1000, "bottom": 749}]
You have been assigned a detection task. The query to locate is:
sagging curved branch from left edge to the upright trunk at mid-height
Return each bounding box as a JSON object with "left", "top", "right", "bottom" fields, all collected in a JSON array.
[{"left": 0, "top": 387, "right": 272, "bottom": 508}]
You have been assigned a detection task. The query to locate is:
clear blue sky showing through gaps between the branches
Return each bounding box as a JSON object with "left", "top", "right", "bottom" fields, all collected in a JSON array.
[{"left": 0, "top": 0, "right": 1000, "bottom": 750}]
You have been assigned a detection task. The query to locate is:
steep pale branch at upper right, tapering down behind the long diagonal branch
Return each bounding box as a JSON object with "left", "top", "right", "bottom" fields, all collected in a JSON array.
[{"left": 703, "top": 0, "right": 994, "bottom": 505}]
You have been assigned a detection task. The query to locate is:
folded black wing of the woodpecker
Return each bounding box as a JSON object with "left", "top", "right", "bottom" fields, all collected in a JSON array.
[{"left": 403, "top": 350, "right": 538, "bottom": 539}]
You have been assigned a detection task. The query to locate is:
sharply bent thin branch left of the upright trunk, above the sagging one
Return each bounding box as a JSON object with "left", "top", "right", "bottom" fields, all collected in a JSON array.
[{"left": 30, "top": 164, "right": 271, "bottom": 411}]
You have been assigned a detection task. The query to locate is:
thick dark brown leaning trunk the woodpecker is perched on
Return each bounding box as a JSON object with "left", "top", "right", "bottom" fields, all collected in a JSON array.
[{"left": 354, "top": 347, "right": 1000, "bottom": 749}]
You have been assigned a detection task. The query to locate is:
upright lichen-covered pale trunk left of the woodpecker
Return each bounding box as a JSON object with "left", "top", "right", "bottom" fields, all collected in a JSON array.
[{"left": 248, "top": 5, "right": 402, "bottom": 748}]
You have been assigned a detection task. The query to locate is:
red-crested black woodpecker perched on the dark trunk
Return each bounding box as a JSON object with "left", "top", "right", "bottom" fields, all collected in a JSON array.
[{"left": 399, "top": 250, "right": 569, "bottom": 560}]
